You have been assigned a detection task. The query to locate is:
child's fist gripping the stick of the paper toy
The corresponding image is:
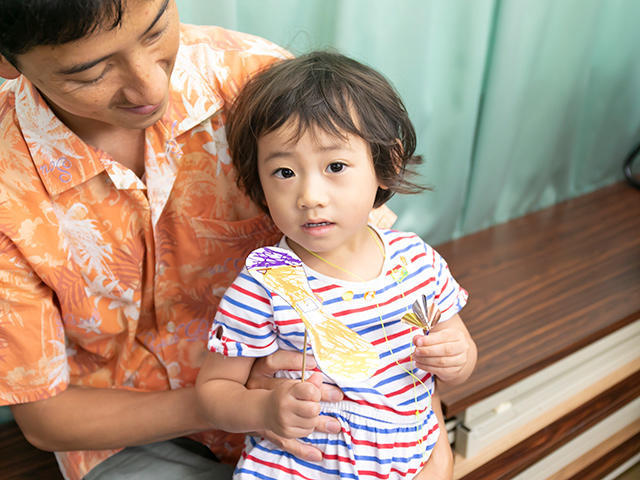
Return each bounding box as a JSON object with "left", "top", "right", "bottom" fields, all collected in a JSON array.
[{"left": 264, "top": 373, "right": 322, "bottom": 438}]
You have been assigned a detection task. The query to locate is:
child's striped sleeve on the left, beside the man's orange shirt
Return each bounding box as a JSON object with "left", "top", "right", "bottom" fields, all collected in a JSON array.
[{"left": 207, "top": 268, "right": 278, "bottom": 357}]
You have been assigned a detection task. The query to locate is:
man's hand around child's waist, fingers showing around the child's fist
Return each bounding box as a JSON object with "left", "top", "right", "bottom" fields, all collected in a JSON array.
[{"left": 247, "top": 350, "right": 343, "bottom": 462}]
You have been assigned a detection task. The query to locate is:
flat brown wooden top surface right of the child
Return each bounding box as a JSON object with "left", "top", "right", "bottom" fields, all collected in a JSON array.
[{"left": 436, "top": 182, "right": 640, "bottom": 416}]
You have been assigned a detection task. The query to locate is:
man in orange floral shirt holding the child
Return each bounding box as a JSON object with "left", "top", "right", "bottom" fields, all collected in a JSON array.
[{"left": 0, "top": 0, "right": 475, "bottom": 479}]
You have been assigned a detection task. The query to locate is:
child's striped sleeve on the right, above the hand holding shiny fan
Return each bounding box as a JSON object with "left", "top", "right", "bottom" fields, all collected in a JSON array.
[{"left": 425, "top": 243, "right": 469, "bottom": 322}]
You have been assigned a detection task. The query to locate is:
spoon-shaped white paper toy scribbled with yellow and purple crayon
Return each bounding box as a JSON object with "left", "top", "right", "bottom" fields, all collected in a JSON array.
[{"left": 245, "top": 247, "right": 380, "bottom": 382}]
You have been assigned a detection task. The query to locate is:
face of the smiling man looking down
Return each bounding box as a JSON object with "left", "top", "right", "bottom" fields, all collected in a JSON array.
[{"left": 9, "top": 0, "right": 179, "bottom": 138}]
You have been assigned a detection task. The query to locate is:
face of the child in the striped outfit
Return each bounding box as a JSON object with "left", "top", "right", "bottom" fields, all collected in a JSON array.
[{"left": 258, "top": 122, "right": 384, "bottom": 253}]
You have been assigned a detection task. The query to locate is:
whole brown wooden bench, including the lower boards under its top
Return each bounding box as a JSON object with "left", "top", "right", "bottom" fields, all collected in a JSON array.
[{"left": 0, "top": 183, "right": 640, "bottom": 480}]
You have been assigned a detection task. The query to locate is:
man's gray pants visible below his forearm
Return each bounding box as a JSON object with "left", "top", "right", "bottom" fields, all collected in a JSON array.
[{"left": 84, "top": 438, "right": 234, "bottom": 480}]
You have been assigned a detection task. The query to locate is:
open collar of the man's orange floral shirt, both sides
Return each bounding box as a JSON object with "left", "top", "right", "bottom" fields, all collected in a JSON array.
[{"left": 14, "top": 35, "right": 223, "bottom": 196}]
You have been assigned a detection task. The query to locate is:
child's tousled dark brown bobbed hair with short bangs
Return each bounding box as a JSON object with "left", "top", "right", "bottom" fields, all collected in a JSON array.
[{"left": 227, "top": 52, "right": 425, "bottom": 212}]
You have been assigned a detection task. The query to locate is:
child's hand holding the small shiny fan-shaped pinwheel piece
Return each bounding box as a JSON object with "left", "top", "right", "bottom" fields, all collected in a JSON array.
[{"left": 413, "top": 315, "right": 477, "bottom": 384}]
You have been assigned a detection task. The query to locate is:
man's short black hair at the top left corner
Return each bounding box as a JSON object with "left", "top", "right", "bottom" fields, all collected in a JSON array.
[{"left": 0, "top": 0, "right": 126, "bottom": 67}]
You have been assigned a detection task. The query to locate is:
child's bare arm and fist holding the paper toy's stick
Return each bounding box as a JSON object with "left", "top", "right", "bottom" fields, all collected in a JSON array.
[{"left": 196, "top": 352, "right": 322, "bottom": 438}]
